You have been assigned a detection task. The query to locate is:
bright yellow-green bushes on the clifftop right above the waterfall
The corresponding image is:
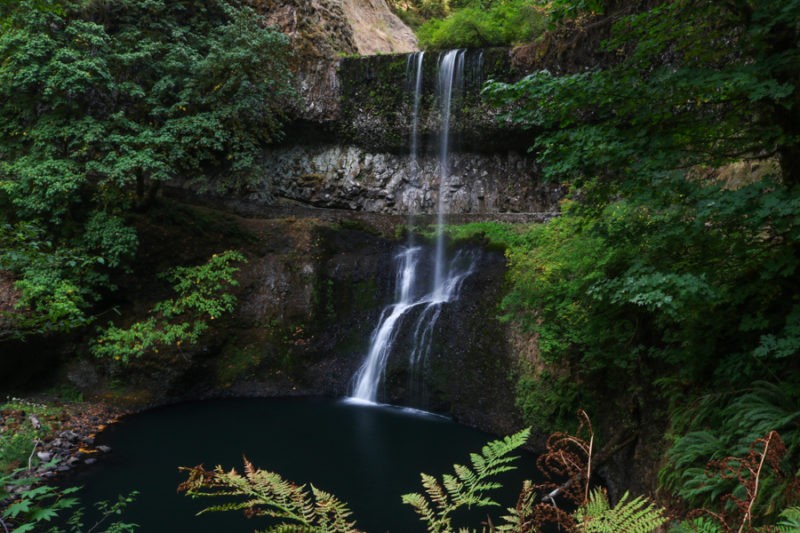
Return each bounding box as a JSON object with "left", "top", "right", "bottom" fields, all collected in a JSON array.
[{"left": 417, "top": 0, "right": 547, "bottom": 49}]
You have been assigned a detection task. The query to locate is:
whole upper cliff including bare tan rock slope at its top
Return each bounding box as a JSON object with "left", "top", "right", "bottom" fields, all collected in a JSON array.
[{"left": 171, "top": 4, "right": 563, "bottom": 214}]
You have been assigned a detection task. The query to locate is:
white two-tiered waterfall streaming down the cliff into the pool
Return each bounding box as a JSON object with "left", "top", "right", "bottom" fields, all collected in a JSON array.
[{"left": 352, "top": 50, "right": 477, "bottom": 403}]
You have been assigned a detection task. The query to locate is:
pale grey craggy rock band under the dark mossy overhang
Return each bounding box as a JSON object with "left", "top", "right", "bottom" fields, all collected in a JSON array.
[{"left": 248, "top": 145, "right": 562, "bottom": 214}]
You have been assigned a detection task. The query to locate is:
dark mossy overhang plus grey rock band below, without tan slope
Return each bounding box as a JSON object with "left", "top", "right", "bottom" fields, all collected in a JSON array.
[{"left": 177, "top": 49, "right": 564, "bottom": 215}]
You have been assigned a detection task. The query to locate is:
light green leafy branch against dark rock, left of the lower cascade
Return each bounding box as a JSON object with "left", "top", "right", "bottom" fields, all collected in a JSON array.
[{"left": 91, "top": 250, "right": 246, "bottom": 363}]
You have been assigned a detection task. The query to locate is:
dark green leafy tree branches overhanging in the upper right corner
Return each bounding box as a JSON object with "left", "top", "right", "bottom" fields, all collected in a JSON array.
[{"left": 487, "top": 0, "right": 800, "bottom": 182}]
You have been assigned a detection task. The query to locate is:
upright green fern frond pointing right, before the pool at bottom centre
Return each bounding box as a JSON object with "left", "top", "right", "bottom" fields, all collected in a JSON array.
[{"left": 403, "top": 429, "right": 530, "bottom": 533}]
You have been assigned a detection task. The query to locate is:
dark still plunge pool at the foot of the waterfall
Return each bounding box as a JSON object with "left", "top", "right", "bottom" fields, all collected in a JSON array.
[{"left": 70, "top": 398, "right": 535, "bottom": 533}]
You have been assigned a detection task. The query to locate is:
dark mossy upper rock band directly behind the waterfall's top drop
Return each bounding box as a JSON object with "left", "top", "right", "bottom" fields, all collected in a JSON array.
[{"left": 338, "top": 48, "right": 520, "bottom": 153}]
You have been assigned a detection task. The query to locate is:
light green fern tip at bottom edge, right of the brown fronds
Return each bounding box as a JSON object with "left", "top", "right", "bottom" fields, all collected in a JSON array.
[{"left": 575, "top": 489, "right": 667, "bottom": 533}]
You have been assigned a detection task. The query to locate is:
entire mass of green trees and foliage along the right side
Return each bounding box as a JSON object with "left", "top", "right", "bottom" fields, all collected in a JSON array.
[{"left": 485, "top": 0, "right": 800, "bottom": 524}]
